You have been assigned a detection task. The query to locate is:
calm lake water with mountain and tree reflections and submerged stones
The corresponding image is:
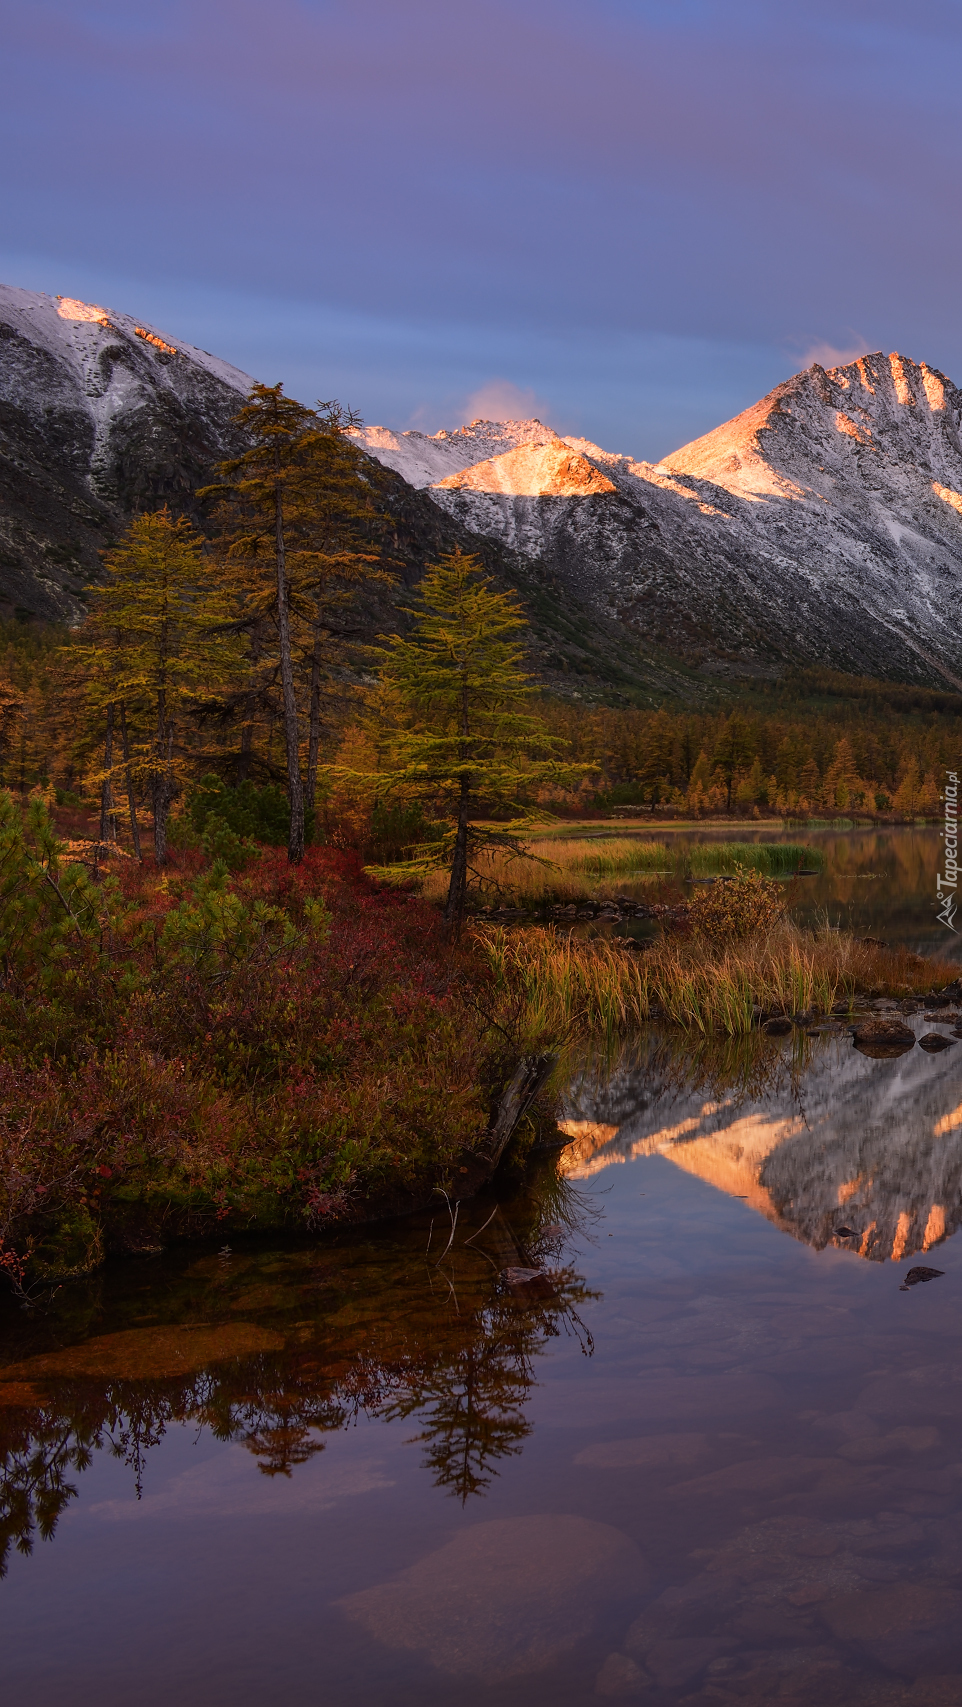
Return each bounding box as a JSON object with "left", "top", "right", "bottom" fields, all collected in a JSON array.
[{"left": 0, "top": 831, "right": 962, "bottom": 1707}]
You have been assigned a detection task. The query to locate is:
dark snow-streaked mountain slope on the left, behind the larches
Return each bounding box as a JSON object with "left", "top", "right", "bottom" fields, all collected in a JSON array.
[{"left": 0, "top": 285, "right": 251, "bottom": 620}]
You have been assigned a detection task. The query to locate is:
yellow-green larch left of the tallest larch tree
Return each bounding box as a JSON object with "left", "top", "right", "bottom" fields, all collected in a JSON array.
[{"left": 82, "top": 509, "right": 239, "bottom": 865}]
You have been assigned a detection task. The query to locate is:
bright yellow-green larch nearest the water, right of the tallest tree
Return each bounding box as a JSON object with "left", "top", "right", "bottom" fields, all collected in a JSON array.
[{"left": 358, "top": 551, "right": 569, "bottom": 935}]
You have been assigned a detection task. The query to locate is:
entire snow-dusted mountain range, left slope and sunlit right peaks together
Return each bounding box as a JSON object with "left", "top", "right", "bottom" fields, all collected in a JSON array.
[{"left": 0, "top": 287, "right": 962, "bottom": 698}]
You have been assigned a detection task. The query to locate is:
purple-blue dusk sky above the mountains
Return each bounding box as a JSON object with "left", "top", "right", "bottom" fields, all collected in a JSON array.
[{"left": 0, "top": 0, "right": 962, "bottom": 459}]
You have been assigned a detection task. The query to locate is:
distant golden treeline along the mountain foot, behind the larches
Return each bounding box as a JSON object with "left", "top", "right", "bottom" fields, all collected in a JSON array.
[{"left": 0, "top": 621, "right": 962, "bottom": 847}]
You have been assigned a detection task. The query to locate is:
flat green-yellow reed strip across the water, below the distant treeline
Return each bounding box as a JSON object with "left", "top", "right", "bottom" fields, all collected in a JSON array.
[{"left": 405, "top": 836, "right": 822, "bottom": 906}]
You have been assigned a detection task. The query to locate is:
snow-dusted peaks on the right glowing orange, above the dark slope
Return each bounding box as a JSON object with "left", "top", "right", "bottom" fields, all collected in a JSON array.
[{"left": 358, "top": 353, "right": 962, "bottom": 685}]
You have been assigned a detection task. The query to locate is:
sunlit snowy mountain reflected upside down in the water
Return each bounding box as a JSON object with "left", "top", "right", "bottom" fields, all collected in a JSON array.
[{"left": 563, "top": 1016, "right": 962, "bottom": 1261}]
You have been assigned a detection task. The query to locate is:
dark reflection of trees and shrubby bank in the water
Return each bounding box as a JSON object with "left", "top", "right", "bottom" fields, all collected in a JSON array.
[{"left": 0, "top": 1168, "right": 592, "bottom": 1574}]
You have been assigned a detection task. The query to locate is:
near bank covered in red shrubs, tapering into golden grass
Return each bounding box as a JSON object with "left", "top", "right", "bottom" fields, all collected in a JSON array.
[{"left": 0, "top": 795, "right": 957, "bottom": 1290}]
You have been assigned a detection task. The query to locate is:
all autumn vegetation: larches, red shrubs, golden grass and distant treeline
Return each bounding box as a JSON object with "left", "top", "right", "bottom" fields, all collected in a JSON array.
[{"left": 0, "top": 386, "right": 962, "bottom": 1297}]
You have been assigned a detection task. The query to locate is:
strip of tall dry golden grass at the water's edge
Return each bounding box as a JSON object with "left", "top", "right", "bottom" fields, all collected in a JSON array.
[{"left": 478, "top": 922, "right": 959, "bottom": 1041}]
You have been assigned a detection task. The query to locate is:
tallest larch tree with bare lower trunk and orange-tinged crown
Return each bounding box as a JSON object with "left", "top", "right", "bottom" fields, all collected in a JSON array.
[{"left": 200, "top": 384, "right": 385, "bottom": 864}]
